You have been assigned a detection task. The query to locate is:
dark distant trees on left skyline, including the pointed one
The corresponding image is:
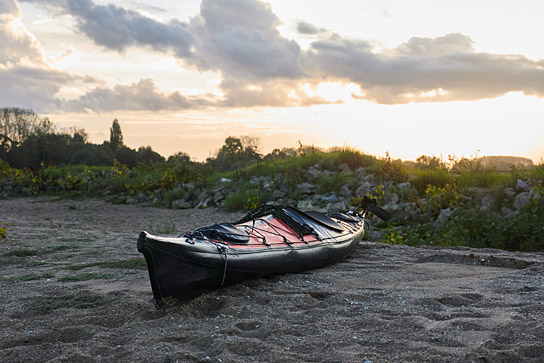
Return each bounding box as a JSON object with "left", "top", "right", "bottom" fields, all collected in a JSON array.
[{"left": 0, "top": 107, "right": 266, "bottom": 171}]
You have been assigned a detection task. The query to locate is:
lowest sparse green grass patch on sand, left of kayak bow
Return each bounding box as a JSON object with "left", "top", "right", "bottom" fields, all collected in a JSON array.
[{"left": 23, "top": 295, "right": 108, "bottom": 314}]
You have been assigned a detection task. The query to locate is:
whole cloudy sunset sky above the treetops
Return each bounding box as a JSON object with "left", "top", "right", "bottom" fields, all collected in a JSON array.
[{"left": 0, "top": 0, "right": 544, "bottom": 162}]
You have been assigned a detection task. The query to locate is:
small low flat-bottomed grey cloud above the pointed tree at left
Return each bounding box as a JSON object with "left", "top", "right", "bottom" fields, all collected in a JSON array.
[{"left": 60, "top": 78, "right": 210, "bottom": 112}]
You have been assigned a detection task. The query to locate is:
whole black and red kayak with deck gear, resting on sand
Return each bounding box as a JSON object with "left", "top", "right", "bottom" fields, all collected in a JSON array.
[{"left": 137, "top": 198, "right": 387, "bottom": 308}]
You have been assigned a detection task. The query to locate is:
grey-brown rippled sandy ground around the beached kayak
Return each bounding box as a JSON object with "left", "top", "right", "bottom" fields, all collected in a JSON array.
[{"left": 0, "top": 198, "right": 544, "bottom": 362}]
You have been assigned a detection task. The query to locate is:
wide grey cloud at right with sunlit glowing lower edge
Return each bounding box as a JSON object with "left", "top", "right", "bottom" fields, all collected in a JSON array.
[{"left": 308, "top": 34, "right": 544, "bottom": 104}]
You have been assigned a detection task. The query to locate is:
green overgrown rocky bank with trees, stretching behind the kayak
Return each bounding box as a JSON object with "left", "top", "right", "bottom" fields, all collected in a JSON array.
[{"left": 0, "top": 109, "right": 544, "bottom": 251}]
